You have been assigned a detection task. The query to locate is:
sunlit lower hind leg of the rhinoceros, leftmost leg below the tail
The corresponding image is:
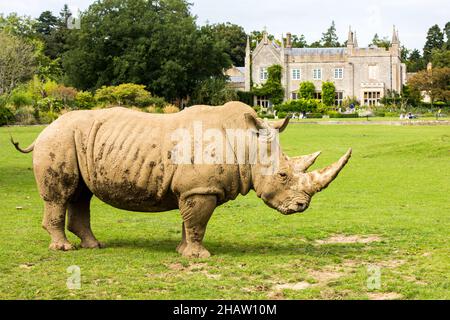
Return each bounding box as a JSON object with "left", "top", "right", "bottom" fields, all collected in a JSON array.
[{"left": 42, "top": 201, "right": 75, "bottom": 251}]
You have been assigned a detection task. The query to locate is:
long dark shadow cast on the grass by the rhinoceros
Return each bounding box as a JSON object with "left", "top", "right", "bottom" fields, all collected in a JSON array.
[{"left": 103, "top": 239, "right": 370, "bottom": 257}]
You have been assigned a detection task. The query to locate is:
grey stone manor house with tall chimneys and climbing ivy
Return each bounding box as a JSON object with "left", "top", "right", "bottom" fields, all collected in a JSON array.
[{"left": 227, "top": 27, "right": 406, "bottom": 107}]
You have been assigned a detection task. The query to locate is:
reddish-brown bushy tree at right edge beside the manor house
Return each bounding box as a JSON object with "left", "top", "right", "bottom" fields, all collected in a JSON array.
[{"left": 408, "top": 67, "right": 450, "bottom": 104}]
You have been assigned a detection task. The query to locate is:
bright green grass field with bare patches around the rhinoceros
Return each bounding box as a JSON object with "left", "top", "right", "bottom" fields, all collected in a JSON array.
[{"left": 0, "top": 124, "right": 450, "bottom": 299}]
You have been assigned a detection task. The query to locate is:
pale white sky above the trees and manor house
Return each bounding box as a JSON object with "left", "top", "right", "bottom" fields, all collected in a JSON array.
[{"left": 0, "top": 0, "right": 450, "bottom": 49}]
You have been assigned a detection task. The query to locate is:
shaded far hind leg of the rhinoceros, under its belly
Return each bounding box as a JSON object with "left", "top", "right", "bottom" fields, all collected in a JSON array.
[{"left": 67, "top": 186, "right": 102, "bottom": 249}]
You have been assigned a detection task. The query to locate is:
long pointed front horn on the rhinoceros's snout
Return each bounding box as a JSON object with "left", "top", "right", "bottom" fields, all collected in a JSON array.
[{"left": 307, "top": 148, "right": 352, "bottom": 194}]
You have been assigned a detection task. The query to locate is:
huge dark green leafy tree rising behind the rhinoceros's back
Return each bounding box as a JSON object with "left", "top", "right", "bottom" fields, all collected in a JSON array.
[{"left": 63, "top": 0, "right": 231, "bottom": 101}]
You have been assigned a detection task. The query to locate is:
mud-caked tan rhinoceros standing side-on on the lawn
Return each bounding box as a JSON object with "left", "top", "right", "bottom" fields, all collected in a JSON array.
[{"left": 11, "top": 102, "right": 351, "bottom": 258}]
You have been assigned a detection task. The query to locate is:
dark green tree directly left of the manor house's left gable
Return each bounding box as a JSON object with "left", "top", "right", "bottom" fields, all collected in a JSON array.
[{"left": 201, "top": 22, "right": 247, "bottom": 66}]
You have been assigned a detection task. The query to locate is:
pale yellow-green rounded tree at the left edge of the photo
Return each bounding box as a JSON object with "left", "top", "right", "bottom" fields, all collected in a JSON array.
[{"left": 0, "top": 31, "right": 36, "bottom": 95}]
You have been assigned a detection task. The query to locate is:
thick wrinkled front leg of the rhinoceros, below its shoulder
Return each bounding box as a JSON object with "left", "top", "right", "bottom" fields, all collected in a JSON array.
[{"left": 177, "top": 195, "right": 217, "bottom": 258}]
